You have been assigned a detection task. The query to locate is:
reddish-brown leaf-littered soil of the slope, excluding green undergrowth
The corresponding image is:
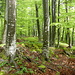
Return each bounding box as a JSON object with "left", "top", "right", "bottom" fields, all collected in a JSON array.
[{"left": 0, "top": 44, "right": 75, "bottom": 75}]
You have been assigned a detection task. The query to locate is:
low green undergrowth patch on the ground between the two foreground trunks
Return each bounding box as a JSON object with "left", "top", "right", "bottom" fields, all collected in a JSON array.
[{"left": 17, "top": 37, "right": 43, "bottom": 53}]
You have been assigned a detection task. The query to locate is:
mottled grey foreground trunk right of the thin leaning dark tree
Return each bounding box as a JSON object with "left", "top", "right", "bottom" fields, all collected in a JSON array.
[{"left": 43, "top": 0, "right": 50, "bottom": 59}]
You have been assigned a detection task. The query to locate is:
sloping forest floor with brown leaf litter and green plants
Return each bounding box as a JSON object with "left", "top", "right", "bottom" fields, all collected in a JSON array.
[{"left": 0, "top": 39, "right": 75, "bottom": 75}]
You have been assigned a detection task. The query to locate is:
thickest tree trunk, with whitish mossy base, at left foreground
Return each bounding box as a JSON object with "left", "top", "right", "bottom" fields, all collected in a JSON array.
[{"left": 5, "top": 0, "right": 16, "bottom": 67}]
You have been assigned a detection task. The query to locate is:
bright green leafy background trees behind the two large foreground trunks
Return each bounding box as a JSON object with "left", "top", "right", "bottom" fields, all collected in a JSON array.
[{"left": 0, "top": 0, "right": 75, "bottom": 60}]
